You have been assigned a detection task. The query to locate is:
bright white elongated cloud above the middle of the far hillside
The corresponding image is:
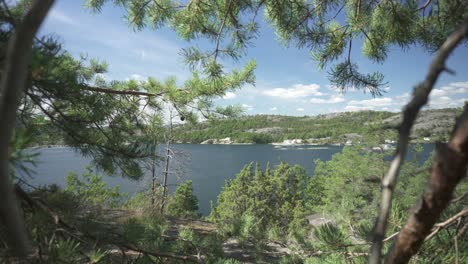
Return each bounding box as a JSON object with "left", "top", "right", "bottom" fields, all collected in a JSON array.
[{"left": 261, "top": 84, "right": 325, "bottom": 99}]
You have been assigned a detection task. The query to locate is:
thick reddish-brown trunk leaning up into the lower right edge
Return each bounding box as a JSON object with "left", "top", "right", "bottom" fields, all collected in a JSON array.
[{"left": 386, "top": 108, "right": 468, "bottom": 263}]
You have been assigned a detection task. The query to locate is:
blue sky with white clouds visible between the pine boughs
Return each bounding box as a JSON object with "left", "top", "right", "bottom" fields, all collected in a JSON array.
[{"left": 40, "top": 0, "right": 468, "bottom": 116}]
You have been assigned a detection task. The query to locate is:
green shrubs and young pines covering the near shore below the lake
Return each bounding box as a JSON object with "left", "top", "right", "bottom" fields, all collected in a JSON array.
[{"left": 1, "top": 147, "right": 468, "bottom": 263}]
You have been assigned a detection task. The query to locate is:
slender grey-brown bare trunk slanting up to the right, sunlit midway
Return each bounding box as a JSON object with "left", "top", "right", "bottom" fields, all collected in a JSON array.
[{"left": 369, "top": 20, "right": 468, "bottom": 264}]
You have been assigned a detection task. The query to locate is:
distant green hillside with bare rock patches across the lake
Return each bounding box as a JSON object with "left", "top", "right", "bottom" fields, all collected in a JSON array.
[{"left": 175, "top": 109, "right": 461, "bottom": 143}]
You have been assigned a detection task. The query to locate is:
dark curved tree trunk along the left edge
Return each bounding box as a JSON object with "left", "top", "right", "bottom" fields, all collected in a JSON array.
[{"left": 0, "top": 0, "right": 54, "bottom": 256}]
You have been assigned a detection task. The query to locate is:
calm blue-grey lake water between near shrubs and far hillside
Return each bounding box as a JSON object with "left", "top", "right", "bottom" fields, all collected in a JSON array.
[{"left": 24, "top": 144, "right": 434, "bottom": 215}]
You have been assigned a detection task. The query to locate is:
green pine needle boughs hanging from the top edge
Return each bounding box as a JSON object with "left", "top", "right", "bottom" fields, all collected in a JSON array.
[{"left": 87, "top": 0, "right": 468, "bottom": 95}]
